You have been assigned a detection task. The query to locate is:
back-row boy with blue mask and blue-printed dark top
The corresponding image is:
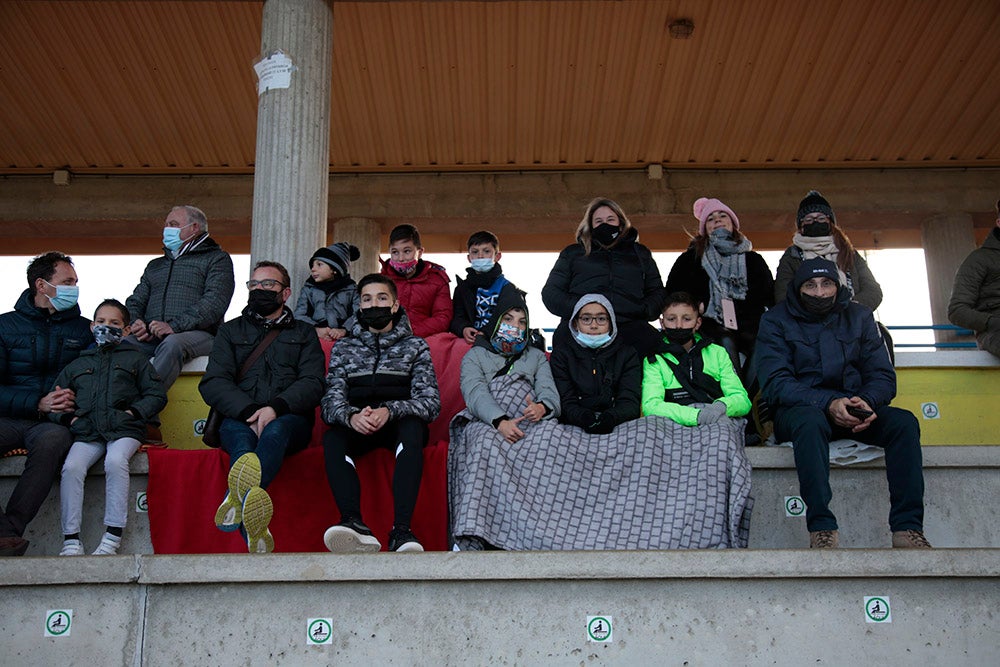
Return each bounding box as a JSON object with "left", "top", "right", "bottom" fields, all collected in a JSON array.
[{"left": 448, "top": 231, "right": 517, "bottom": 345}]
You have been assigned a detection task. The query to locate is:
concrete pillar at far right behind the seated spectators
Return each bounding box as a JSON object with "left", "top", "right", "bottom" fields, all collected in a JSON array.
[{"left": 920, "top": 213, "right": 976, "bottom": 342}]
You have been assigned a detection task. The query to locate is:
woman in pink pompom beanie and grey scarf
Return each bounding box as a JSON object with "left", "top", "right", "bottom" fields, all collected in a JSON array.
[{"left": 666, "top": 197, "right": 774, "bottom": 390}]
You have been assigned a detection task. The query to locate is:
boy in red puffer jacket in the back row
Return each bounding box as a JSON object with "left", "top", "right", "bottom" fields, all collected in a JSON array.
[{"left": 379, "top": 225, "right": 452, "bottom": 338}]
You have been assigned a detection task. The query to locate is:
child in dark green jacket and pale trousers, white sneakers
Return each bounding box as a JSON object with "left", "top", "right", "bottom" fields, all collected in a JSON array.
[{"left": 51, "top": 299, "right": 167, "bottom": 556}]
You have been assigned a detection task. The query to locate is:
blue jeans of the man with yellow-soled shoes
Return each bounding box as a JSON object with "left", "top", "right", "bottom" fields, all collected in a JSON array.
[{"left": 219, "top": 414, "right": 312, "bottom": 488}]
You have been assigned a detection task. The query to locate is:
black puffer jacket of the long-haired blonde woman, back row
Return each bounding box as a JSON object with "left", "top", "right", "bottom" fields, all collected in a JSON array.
[{"left": 542, "top": 227, "right": 665, "bottom": 323}]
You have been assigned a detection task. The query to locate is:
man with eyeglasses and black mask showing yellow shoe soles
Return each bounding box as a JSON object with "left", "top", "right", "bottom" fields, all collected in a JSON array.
[{"left": 198, "top": 262, "right": 326, "bottom": 553}]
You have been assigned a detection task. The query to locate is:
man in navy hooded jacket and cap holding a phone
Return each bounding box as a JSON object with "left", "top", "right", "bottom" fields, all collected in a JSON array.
[{"left": 757, "top": 258, "right": 930, "bottom": 548}]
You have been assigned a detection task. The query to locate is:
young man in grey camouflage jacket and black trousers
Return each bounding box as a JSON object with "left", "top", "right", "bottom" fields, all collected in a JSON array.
[{"left": 322, "top": 273, "right": 441, "bottom": 553}]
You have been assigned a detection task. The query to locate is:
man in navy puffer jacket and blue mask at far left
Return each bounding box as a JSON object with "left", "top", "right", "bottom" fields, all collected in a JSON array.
[{"left": 0, "top": 252, "right": 93, "bottom": 556}]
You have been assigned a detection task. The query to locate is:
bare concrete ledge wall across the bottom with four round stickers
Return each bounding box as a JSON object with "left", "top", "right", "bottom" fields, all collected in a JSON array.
[{"left": 0, "top": 549, "right": 1000, "bottom": 666}]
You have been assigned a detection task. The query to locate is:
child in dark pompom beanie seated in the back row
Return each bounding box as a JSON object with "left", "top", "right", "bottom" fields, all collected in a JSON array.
[{"left": 294, "top": 242, "right": 361, "bottom": 340}]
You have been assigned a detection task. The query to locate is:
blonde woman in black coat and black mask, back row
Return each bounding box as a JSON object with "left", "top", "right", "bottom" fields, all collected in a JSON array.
[{"left": 542, "top": 198, "right": 664, "bottom": 355}]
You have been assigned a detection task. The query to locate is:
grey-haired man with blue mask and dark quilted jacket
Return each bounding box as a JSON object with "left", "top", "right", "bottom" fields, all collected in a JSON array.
[{"left": 125, "top": 206, "right": 235, "bottom": 389}]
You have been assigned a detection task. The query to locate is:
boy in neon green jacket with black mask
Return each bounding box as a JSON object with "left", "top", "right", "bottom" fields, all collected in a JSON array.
[{"left": 642, "top": 292, "right": 750, "bottom": 426}]
